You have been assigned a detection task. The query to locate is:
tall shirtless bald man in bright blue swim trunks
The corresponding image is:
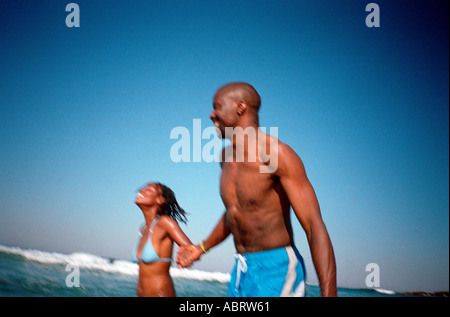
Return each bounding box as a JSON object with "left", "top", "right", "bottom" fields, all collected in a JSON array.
[{"left": 177, "top": 83, "right": 337, "bottom": 297}]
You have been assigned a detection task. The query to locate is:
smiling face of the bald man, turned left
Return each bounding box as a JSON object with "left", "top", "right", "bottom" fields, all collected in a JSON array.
[{"left": 209, "top": 90, "right": 239, "bottom": 138}]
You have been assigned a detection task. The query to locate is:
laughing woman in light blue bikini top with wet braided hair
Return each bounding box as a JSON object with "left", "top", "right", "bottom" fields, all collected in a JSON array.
[{"left": 133, "top": 183, "right": 192, "bottom": 297}]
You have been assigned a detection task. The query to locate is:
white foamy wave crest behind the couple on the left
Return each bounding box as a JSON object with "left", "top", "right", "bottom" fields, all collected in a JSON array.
[{"left": 0, "top": 245, "right": 230, "bottom": 283}]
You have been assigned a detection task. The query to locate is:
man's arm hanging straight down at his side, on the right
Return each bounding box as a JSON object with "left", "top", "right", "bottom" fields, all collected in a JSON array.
[{"left": 276, "top": 142, "right": 337, "bottom": 296}]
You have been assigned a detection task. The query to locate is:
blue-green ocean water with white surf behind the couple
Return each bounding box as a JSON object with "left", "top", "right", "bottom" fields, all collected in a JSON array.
[{"left": 0, "top": 245, "right": 404, "bottom": 297}]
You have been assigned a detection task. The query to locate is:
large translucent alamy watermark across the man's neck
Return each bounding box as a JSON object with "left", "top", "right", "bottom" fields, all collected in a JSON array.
[{"left": 170, "top": 119, "right": 278, "bottom": 173}]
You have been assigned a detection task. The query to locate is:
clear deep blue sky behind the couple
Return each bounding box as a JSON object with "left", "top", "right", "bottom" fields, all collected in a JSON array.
[{"left": 0, "top": 0, "right": 449, "bottom": 291}]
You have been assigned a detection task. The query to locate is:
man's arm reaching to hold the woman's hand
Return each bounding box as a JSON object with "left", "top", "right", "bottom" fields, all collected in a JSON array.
[{"left": 177, "top": 211, "right": 231, "bottom": 267}]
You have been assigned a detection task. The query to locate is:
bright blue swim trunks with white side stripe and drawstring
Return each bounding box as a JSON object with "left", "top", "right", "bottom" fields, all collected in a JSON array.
[{"left": 227, "top": 246, "right": 306, "bottom": 297}]
